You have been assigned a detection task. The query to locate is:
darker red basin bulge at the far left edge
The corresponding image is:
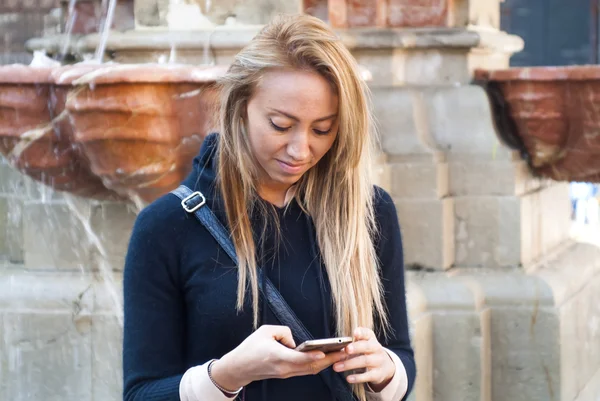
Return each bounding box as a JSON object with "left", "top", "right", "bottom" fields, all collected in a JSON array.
[{"left": 0, "top": 65, "right": 115, "bottom": 199}]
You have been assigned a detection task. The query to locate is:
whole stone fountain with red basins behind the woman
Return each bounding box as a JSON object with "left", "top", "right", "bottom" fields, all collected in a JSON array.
[{"left": 0, "top": 0, "right": 600, "bottom": 401}]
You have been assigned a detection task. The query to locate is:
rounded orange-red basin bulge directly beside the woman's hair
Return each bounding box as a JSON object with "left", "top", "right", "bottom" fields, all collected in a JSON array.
[{"left": 61, "top": 64, "right": 226, "bottom": 202}]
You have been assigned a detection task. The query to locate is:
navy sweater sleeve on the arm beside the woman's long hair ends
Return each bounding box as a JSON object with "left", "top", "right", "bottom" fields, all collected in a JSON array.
[{"left": 375, "top": 188, "right": 416, "bottom": 401}]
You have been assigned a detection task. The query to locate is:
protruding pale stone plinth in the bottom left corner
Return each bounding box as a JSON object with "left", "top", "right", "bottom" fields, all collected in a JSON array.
[{"left": 0, "top": 266, "right": 122, "bottom": 401}]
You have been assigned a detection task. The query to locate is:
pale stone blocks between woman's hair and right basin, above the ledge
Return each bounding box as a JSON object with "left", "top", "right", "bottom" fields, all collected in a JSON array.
[{"left": 373, "top": 81, "right": 571, "bottom": 269}]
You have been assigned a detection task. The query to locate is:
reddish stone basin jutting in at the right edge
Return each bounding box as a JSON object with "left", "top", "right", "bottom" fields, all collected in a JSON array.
[{"left": 475, "top": 66, "right": 600, "bottom": 182}]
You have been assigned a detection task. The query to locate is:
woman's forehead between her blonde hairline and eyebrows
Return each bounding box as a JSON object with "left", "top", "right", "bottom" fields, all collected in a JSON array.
[{"left": 252, "top": 69, "right": 338, "bottom": 118}]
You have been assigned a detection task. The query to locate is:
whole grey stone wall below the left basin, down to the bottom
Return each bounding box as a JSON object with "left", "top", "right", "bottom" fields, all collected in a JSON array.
[{"left": 0, "top": 155, "right": 131, "bottom": 401}]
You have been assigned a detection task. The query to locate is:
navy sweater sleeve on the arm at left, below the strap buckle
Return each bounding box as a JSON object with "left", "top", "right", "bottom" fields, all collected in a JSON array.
[{"left": 123, "top": 198, "right": 186, "bottom": 401}]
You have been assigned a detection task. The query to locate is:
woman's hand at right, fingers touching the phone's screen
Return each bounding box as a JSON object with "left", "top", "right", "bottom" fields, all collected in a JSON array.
[{"left": 333, "top": 327, "right": 396, "bottom": 392}]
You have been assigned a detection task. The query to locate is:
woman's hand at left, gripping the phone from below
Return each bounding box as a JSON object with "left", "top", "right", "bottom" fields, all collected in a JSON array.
[{"left": 211, "top": 325, "right": 347, "bottom": 391}]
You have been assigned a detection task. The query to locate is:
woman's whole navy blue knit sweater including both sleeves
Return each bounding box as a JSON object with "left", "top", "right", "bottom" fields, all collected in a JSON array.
[{"left": 123, "top": 134, "right": 415, "bottom": 401}]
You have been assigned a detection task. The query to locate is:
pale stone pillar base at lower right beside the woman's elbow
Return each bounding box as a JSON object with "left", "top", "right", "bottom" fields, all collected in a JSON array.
[{"left": 408, "top": 243, "right": 600, "bottom": 401}]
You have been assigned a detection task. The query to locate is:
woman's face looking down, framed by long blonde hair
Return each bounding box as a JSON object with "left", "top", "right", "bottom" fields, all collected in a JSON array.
[{"left": 247, "top": 69, "right": 338, "bottom": 198}]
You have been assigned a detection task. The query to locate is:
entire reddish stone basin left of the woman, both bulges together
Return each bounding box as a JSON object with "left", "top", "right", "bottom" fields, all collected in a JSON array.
[{"left": 0, "top": 64, "right": 226, "bottom": 203}]
